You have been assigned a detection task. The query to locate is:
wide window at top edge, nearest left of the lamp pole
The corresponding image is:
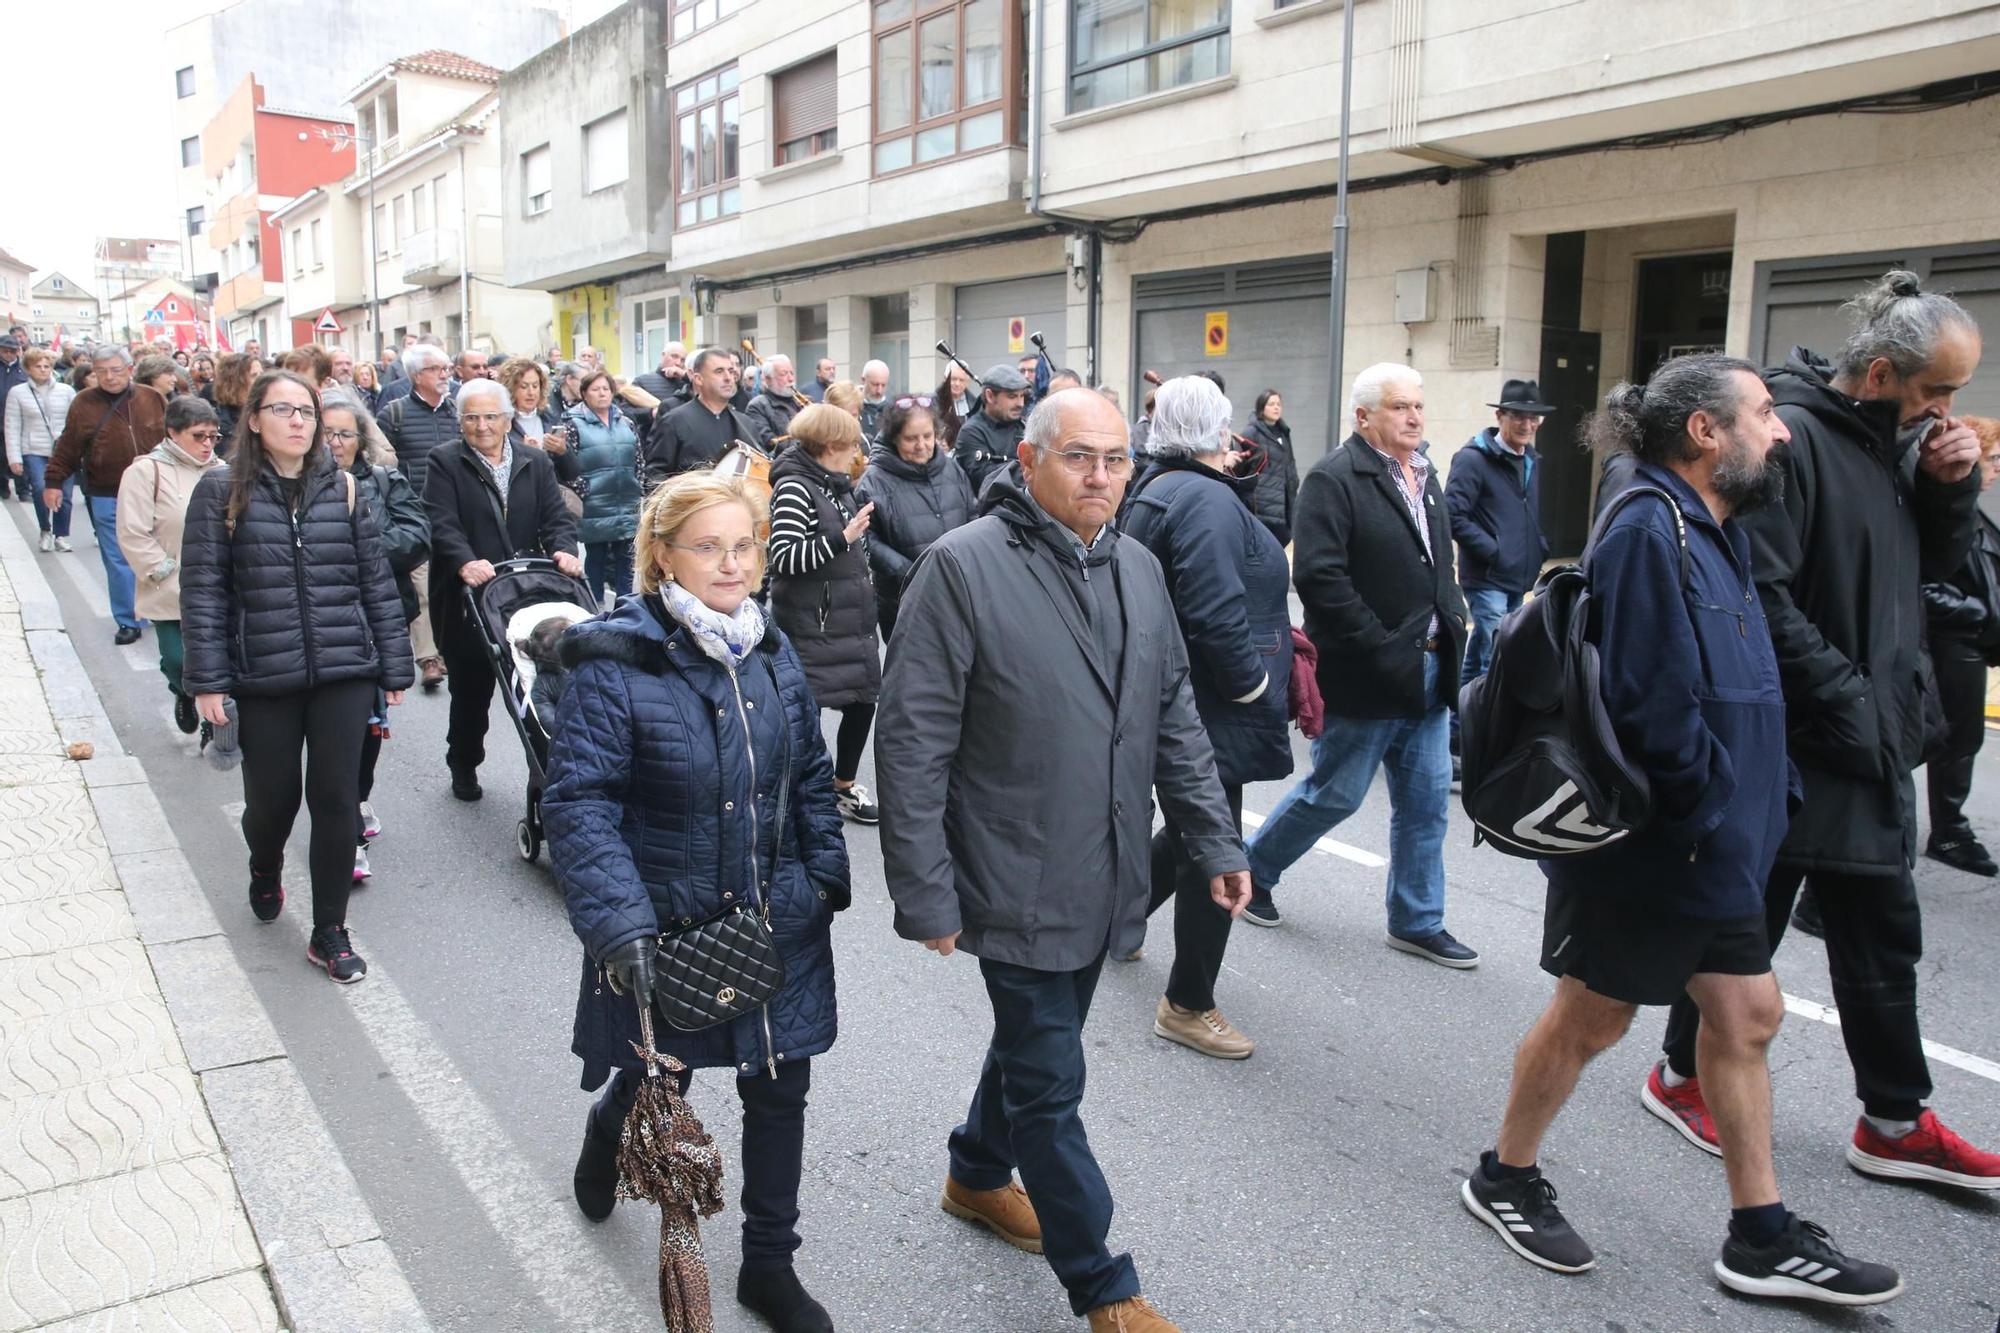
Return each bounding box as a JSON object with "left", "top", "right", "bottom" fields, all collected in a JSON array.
[{"left": 1070, "top": 0, "right": 1230, "bottom": 112}]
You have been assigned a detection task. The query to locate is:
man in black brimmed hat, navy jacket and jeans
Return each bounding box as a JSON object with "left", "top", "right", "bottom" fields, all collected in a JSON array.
[{"left": 1444, "top": 380, "right": 1556, "bottom": 756}]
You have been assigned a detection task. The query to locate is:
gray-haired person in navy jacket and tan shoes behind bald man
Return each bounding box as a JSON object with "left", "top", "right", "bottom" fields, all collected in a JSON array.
[{"left": 1112, "top": 376, "right": 1292, "bottom": 1061}]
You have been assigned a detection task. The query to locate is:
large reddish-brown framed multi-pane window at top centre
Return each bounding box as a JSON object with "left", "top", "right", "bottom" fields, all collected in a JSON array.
[{"left": 874, "top": 0, "right": 1022, "bottom": 174}]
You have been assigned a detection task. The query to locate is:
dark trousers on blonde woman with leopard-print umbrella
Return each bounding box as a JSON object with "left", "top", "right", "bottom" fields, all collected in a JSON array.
[{"left": 592, "top": 1061, "right": 812, "bottom": 1269}]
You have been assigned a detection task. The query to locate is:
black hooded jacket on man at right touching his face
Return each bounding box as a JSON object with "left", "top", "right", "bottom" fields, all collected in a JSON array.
[{"left": 1744, "top": 348, "right": 1978, "bottom": 875}]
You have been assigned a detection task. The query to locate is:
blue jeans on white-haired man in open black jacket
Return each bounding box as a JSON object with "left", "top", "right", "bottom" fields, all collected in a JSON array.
[{"left": 1246, "top": 652, "right": 1452, "bottom": 939}]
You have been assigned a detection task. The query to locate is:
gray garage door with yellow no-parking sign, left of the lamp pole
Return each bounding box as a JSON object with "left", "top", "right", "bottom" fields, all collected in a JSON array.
[{"left": 1132, "top": 256, "right": 1334, "bottom": 470}]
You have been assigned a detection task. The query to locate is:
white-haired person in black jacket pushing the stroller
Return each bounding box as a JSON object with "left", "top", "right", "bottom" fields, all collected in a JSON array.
[{"left": 424, "top": 370, "right": 584, "bottom": 801}]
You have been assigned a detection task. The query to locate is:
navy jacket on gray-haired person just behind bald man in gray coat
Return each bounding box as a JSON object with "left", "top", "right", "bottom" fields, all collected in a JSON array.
[{"left": 1120, "top": 458, "right": 1292, "bottom": 785}]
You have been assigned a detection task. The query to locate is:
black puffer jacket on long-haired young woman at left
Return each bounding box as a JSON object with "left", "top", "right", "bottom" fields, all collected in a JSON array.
[{"left": 180, "top": 454, "right": 414, "bottom": 697}]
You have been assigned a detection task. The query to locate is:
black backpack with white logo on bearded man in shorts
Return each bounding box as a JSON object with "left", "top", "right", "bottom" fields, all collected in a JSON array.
[{"left": 1458, "top": 486, "right": 1690, "bottom": 861}]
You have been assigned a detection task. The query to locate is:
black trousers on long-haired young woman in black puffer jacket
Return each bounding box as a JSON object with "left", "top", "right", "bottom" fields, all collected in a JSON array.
[{"left": 236, "top": 681, "right": 376, "bottom": 927}]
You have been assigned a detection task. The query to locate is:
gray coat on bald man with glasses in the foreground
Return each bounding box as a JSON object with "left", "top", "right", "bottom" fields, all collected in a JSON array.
[{"left": 876, "top": 476, "right": 1248, "bottom": 971}]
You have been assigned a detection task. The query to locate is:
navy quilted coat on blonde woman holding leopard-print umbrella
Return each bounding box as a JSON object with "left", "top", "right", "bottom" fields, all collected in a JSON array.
[{"left": 542, "top": 596, "right": 850, "bottom": 1089}]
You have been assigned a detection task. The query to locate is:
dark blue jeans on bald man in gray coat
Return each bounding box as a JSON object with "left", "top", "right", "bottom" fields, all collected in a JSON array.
[{"left": 950, "top": 955, "right": 1138, "bottom": 1315}]
